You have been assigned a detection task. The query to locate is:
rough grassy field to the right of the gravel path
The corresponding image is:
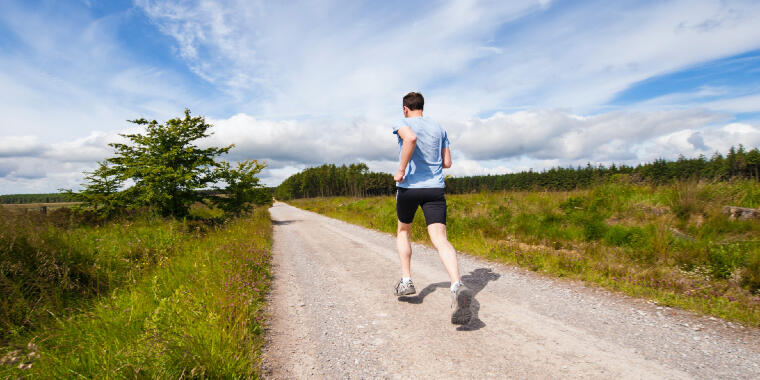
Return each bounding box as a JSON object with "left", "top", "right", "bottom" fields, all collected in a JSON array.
[{"left": 291, "top": 178, "right": 760, "bottom": 326}]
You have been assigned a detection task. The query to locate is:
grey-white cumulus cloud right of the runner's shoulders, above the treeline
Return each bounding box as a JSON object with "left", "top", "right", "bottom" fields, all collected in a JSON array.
[{"left": 450, "top": 109, "right": 726, "bottom": 162}]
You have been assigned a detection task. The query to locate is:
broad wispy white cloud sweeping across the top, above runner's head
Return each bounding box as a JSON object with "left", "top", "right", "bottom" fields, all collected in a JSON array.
[{"left": 138, "top": 0, "right": 760, "bottom": 119}]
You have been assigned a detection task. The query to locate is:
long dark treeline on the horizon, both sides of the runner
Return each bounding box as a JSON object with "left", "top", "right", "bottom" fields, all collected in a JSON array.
[{"left": 274, "top": 145, "right": 760, "bottom": 200}]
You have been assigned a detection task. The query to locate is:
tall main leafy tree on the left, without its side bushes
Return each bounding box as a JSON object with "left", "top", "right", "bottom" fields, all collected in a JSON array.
[{"left": 107, "top": 109, "right": 233, "bottom": 217}]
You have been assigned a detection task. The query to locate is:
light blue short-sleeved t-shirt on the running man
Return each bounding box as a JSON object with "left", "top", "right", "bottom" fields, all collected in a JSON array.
[{"left": 393, "top": 116, "right": 449, "bottom": 189}]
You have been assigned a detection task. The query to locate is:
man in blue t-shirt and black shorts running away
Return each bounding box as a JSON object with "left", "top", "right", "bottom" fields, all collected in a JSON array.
[{"left": 393, "top": 92, "right": 473, "bottom": 325}]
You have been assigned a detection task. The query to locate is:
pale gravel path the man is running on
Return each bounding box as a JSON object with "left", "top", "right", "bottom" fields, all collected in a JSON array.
[{"left": 264, "top": 203, "right": 760, "bottom": 379}]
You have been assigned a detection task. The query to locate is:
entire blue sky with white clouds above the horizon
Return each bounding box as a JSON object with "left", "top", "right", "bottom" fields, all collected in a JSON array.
[{"left": 0, "top": 0, "right": 760, "bottom": 194}]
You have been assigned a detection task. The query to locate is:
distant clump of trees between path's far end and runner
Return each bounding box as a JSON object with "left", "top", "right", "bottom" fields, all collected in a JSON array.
[{"left": 274, "top": 163, "right": 396, "bottom": 200}]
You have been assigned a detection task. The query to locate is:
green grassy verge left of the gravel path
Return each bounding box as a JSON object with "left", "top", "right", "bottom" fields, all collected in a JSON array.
[{"left": 0, "top": 207, "right": 271, "bottom": 378}]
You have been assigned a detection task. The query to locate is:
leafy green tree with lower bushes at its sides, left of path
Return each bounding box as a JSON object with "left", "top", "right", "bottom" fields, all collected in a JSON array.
[{"left": 63, "top": 110, "right": 272, "bottom": 217}]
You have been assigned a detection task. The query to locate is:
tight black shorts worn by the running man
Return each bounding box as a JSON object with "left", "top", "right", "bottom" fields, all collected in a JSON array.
[{"left": 396, "top": 187, "right": 446, "bottom": 226}]
